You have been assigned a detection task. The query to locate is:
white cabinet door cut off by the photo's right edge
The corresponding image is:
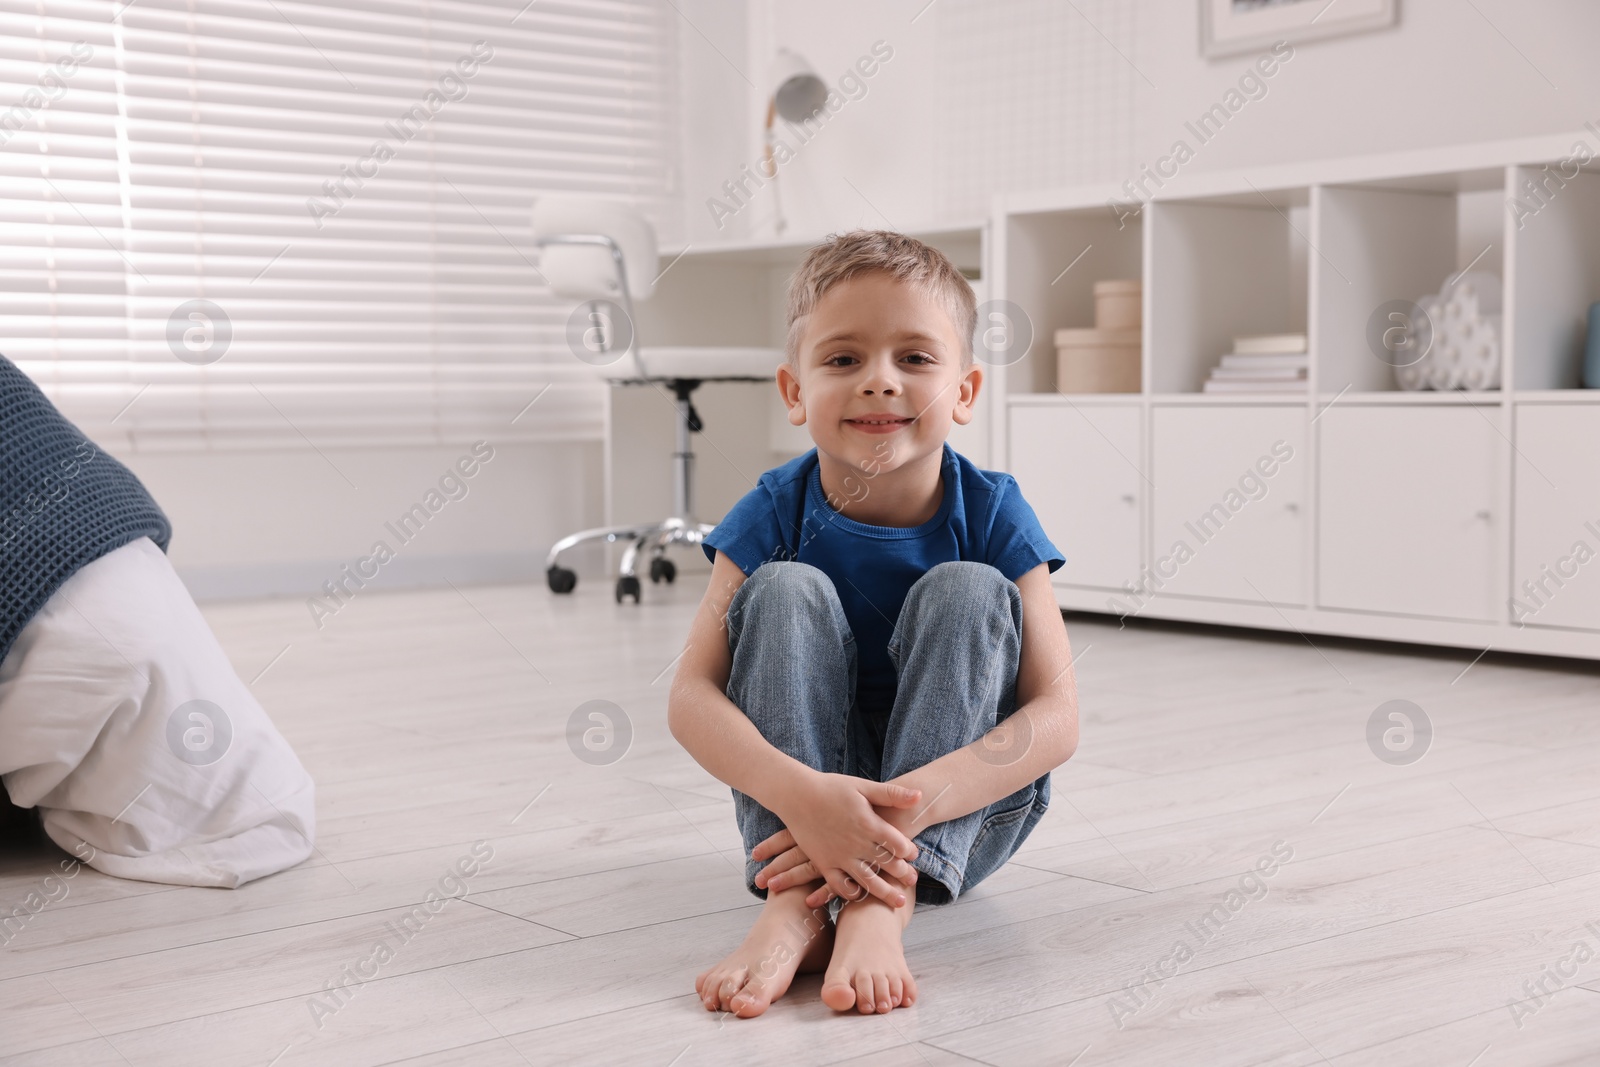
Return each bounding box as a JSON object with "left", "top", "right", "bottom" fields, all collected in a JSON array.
[{"left": 1509, "top": 403, "right": 1600, "bottom": 630}]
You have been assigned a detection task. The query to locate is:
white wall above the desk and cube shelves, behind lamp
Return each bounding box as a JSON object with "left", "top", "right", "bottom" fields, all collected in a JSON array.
[{"left": 682, "top": 0, "right": 1600, "bottom": 242}]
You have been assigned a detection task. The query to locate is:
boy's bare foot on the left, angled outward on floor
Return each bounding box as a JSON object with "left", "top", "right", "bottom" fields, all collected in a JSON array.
[{"left": 694, "top": 878, "right": 834, "bottom": 1019}]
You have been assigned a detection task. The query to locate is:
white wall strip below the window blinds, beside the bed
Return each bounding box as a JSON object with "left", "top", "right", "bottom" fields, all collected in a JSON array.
[{"left": 117, "top": 442, "right": 603, "bottom": 604}]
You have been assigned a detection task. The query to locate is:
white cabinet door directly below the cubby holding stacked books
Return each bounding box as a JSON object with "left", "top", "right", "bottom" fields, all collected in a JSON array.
[{"left": 1146, "top": 405, "right": 1307, "bottom": 605}]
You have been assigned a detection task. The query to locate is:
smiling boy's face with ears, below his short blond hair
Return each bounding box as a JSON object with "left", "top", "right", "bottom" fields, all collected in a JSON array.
[{"left": 778, "top": 272, "right": 982, "bottom": 470}]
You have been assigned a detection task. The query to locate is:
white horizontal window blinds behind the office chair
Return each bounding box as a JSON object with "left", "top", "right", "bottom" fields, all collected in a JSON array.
[{"left": 0, "top": 0, "right": 678, "bottom": 450}]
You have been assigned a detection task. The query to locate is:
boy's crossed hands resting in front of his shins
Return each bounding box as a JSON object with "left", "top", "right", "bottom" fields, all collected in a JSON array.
[{"left": 750, "top": 773, "right": 922, "bottom": 907}]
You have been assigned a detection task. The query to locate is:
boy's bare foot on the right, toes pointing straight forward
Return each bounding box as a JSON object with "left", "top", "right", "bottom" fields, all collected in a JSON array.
[{"left": 822, "top": 886, "right": 917, "bottom": 1014}]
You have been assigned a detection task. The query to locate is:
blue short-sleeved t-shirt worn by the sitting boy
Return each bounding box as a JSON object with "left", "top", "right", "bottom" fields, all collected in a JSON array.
[{"left": 701, "top": 445, "right": 1066, "bottom": 712}]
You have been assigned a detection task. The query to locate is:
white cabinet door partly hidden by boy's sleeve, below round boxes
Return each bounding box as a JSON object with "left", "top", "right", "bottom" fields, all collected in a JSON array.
[{"left": 1010, "top": 405, "right": 1142, "bottom": 589}]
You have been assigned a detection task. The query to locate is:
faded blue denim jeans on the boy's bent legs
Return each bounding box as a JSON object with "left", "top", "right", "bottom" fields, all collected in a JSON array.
[{"left": 728, "top": 561, "right": 1050, "bottom": 915}]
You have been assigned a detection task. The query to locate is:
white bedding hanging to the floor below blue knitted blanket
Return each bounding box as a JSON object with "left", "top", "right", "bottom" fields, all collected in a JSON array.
[{"left": 0, "top": 537, "right": 315, "bottom": 888}]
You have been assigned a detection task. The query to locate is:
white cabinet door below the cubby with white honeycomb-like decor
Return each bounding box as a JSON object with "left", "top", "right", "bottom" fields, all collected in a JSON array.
[{"left": 1317, "top": 405, "right": 1506, "bottom": 622}]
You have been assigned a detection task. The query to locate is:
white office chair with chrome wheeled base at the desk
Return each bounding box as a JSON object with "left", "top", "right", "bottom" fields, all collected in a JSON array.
[{"left": 533, "top": 195, "right": 782, "bottom": 605}]
